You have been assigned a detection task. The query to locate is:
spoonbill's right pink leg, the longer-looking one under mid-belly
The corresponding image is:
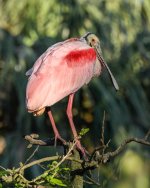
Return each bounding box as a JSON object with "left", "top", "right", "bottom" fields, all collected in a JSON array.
[{"left": 67, "top": 93, "right": 86, "bottom": 157}]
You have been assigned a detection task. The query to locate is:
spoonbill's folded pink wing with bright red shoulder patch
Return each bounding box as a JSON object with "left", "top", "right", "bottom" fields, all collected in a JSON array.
[{"left": 26, "top": 39, "right": 99, "bottom": 111}]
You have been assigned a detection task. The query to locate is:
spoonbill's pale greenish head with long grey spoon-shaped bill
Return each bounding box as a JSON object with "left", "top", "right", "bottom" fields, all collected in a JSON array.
[{"left": 81, "top": 32, "right": 119, "bottom": 90}]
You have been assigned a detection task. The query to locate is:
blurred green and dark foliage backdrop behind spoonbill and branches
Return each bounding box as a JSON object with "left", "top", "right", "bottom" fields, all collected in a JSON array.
[{"left": 0, "top": 0, "right": 150, "bottom": 188}]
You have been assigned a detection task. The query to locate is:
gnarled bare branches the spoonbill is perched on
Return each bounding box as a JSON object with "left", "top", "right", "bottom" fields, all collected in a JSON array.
[{"left": 0, "top": 127, "right": 150, "bottom": 187}]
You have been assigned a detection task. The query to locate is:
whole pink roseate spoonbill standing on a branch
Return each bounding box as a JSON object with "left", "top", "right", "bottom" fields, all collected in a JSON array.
[{"left": 26, "top": 33, "right": 119, "bottom": 155}]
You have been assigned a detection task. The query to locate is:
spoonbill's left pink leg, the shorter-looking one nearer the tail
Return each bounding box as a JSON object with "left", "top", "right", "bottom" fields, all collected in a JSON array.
[{"left": 47, "top": 109, "right": 66, "bottom": 146}]
